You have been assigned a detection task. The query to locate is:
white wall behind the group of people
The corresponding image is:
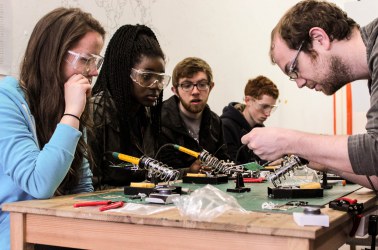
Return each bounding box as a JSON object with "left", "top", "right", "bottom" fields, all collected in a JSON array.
[{"left": 0, "top": 0, "right": 370, "bottom": 134}]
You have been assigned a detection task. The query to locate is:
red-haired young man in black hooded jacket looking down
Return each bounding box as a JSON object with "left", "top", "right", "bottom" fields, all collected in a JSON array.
[{"left": 221, "top": 76, "right": 279, "bottom": 164}]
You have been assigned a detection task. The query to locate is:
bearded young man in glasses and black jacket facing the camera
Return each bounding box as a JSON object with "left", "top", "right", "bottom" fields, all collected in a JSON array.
[{"left": 158, "top": 57, "right": 229, "bottom": 177}]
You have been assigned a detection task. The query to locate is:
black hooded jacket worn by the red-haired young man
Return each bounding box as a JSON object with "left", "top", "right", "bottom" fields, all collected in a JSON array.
[{"left": 220, "top": 102, "right": 265, "bottom": 164}]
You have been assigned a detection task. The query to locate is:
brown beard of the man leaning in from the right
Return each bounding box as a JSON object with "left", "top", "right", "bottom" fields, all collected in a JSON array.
[{"left": 322, "top": 56, "right": 353, "bottom": 95}]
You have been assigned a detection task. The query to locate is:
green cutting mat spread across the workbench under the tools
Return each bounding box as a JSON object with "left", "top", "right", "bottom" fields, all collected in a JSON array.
[{"left": 75, "top": 181, "right": 361, "bottom": 213}]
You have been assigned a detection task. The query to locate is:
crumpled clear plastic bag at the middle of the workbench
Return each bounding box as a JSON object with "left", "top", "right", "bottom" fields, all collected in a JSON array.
[{"left": 173, "top": 185, "right": 247, "bottom": 221}]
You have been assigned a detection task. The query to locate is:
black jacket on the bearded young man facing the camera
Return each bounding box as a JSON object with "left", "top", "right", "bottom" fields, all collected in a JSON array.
[{"left": 157, "top": 96, "right": 229, "bottom": 169}]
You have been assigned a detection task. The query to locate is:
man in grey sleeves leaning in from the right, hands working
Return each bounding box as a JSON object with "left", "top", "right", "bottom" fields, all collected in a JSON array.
[{"left": 242, "top": 0, "right": 378, "bottom": 191}]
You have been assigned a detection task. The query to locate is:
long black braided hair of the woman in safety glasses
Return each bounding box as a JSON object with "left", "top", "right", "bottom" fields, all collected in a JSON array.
[{"left": 92, "top": 24, "right": 165, "bottom": 150}]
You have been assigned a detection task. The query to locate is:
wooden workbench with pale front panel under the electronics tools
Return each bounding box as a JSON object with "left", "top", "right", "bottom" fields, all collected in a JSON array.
[{"left": 3, "top": 188, "right": 376, "bottom": 250}]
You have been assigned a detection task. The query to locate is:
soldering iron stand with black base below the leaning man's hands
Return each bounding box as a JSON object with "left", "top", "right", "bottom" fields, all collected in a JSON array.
[{"left": 268, "top": 155, "right": 323, "bottom": 198}]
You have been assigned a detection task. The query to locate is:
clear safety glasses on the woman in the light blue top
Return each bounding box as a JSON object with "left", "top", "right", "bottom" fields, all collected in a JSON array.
[{"left": 66, "top": 50, "right": 104, "bottom": 75}]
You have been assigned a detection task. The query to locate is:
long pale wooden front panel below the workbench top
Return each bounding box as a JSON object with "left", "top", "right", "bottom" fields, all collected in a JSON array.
[{"left": 27, "top": 215, "right": 312, "bottom": 250}]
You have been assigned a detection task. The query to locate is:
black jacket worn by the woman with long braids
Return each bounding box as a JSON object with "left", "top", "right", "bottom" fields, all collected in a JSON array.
[{"left": 88, "top": 92, "right": 151, "bottom": 189}]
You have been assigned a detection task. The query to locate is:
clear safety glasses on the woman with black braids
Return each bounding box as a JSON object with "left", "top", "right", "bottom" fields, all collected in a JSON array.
[{"left": 130, "top": 68, "right": 171, "bottom": 90}]
